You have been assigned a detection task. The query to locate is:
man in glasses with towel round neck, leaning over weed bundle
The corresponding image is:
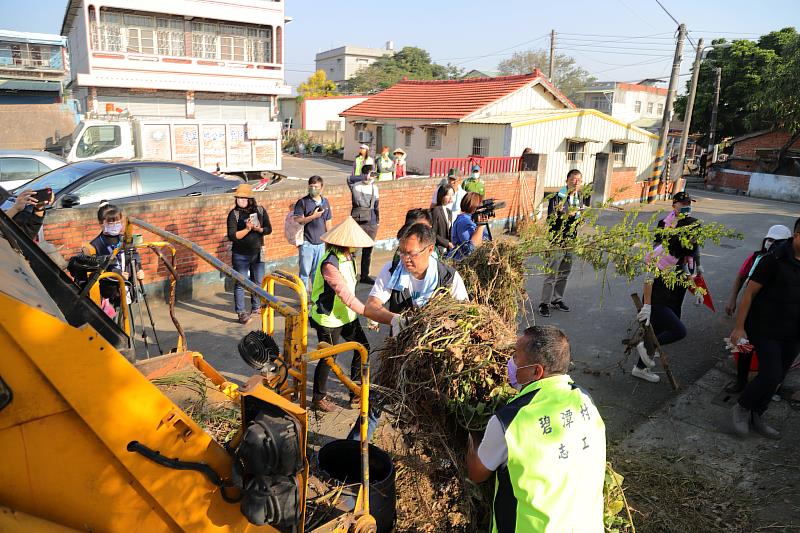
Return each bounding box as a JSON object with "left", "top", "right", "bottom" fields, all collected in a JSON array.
[{"left": 364, "top": 223, "right": 468, "bottom": 335}]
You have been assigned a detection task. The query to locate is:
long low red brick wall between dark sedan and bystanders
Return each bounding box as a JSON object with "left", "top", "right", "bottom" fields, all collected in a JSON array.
[{"left": 44, "top": 173, "right": 536, "bottom": 283}]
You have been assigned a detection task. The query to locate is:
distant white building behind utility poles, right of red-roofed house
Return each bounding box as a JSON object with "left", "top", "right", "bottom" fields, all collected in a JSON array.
[{"left": 580, "top": 80, "right": 667, "bottom": 129}]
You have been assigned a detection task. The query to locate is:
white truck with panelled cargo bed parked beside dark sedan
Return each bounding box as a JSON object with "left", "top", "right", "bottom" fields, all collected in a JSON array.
[{"left": 67, "top": 117, "right": 281, "bottom": 179}]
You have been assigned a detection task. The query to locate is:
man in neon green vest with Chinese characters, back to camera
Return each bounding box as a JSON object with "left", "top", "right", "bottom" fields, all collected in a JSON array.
[{"left": 466, "top": 326, "right": 606, "bottom": 533}]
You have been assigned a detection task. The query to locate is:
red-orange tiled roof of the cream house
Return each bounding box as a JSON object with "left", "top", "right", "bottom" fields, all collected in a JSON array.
[{"left": 340, "top": 69, "right": 572, "bottom": 119}]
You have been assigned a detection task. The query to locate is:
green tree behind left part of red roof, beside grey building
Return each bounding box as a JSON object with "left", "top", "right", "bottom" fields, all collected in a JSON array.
[{"left": 343, "top": 46, "right": 461, "bottom": 94}]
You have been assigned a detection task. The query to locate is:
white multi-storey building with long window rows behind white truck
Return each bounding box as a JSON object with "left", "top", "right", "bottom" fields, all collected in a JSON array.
[{"left": 61, "top": 0, "right": 290, "bottom": 121}]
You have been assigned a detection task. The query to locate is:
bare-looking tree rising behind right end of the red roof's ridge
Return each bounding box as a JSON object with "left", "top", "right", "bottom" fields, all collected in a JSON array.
[{"left": 497, "top": 50, "right": 595, "bottom": 101}]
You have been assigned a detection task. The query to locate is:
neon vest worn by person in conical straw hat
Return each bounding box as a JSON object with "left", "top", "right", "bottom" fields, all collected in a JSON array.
[{"left": 311, "top": 249, "right": 358, "bottom": 328}]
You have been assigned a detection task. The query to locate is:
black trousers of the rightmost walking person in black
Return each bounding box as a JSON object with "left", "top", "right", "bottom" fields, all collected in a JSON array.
[{"left": 739, "top": 335, "right": 800, "bottom": 414}]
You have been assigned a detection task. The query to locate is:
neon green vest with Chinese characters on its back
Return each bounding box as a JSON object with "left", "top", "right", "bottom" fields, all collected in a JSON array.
[{"left": 492, "top": 374, "right": 606, "bottom": 533}]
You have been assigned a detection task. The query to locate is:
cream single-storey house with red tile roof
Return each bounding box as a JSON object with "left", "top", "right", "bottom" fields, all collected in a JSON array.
[{"left": 341, "top": 69, "right": 655, "bottom": 191}]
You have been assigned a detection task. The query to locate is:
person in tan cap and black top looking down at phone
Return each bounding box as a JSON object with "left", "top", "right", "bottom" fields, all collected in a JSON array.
[{"left": 228, "top": 183, "right": 272, "bottom": 324}]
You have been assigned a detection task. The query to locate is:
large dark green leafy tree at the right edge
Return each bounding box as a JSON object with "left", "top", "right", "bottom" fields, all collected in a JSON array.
[{"left": 675, "top": 28, "right": 800, "bottom": 143}]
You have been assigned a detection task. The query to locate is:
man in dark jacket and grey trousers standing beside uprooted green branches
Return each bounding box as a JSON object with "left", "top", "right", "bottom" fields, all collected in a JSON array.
[{"left": 539, "top": 168, "right": 590, "bottom": 317}]
